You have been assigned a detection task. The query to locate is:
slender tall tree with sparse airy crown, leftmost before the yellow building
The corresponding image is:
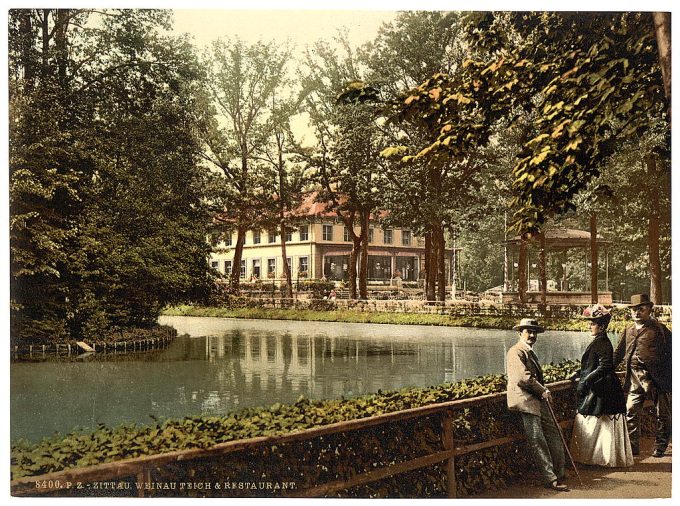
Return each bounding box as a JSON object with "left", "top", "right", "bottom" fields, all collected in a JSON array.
[{"left": 202, "top": 39, "right": 291, "bottom": 290}]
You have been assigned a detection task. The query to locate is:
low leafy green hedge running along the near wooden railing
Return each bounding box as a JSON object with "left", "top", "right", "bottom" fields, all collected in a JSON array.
[{"left": 11, "top": 362, "right": 579, "bottom": 478}]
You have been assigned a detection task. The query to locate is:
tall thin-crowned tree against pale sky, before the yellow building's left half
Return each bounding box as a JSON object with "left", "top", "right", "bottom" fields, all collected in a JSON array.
[{"left": 199, "top": 38, "right": 299, "bottom": 289}]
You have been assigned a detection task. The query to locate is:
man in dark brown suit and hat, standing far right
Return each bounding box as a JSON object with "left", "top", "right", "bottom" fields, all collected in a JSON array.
[{"left": 614, "top": 293, "right": 672, "bottom": 457}]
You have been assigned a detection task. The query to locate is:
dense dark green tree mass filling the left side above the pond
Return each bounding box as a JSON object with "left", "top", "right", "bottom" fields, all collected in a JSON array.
[{"left": 9, "top": 9, "right": 210, "bottom": 340}]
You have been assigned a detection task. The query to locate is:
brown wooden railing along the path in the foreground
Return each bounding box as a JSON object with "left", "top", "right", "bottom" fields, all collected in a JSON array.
[{"left": 11, "top": 381, "right": 573, "bottom": 497}]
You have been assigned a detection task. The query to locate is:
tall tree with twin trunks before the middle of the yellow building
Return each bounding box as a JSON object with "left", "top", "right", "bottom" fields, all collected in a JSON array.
[{"left": 301, "top": 33, "right": 380, "bottom": 299}]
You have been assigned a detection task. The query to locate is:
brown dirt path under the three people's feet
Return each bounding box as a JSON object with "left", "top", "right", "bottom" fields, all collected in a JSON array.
[{"left": 475, "top": 439, "right": 672, "bottom": 499}]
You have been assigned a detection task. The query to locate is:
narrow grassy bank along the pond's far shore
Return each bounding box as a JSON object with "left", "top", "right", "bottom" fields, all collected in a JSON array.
[{"left": 163, "top": 306, "right": 626, "bottom": 332}]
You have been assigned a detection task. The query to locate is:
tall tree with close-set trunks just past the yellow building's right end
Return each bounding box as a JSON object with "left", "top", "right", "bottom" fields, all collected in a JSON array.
[{"left": 366, "top": 12, "right": 502, "bottom": 300}]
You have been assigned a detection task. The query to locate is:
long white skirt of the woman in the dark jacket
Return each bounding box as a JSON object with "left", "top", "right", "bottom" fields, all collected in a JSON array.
[{"left": 569, "top": 413, "right": 633, "bottom": 467}]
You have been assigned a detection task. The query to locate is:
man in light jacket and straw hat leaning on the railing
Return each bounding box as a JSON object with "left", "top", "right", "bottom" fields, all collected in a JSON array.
[{"left": 506, "top": 318, "right": 569, "bottom": 492}]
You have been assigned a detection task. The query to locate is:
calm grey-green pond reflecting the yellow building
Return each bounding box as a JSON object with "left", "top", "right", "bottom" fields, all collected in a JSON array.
[{"left": 10, "top": 316, "right": 589, "bottom": 441}]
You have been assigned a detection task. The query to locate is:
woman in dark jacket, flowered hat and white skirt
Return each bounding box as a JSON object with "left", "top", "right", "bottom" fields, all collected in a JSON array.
[{"left": 570, "top": 304, "right": 633, "bottom": 467}]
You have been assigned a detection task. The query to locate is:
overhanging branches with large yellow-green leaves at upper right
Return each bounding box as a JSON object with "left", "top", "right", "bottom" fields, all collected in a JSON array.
[{"left": 380, "top": 13, "right": 668, "bottom": 233}]
